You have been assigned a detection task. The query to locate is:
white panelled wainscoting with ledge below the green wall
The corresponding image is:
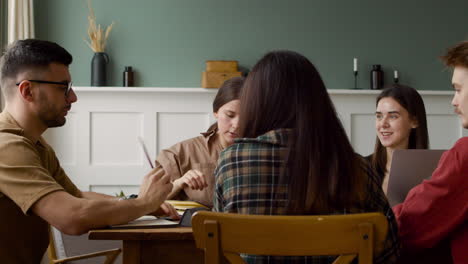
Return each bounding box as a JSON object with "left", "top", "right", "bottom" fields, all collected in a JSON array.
[{"left": 45, "top": 87, "right": 468, "bottom": 194}]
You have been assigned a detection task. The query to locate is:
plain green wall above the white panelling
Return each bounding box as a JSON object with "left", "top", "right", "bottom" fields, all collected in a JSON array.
[{"left": 35, "top": 0, "right": 468, "bottom": 90}]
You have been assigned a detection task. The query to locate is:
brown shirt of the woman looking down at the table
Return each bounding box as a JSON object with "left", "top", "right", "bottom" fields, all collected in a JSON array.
[{"left": 156, "top": 130, "right": 223, "bottom": 207}]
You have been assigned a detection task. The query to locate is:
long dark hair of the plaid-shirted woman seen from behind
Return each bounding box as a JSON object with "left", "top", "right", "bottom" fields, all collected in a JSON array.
[{"left": 239, "top": 51, "right": 364, "bottom": 214}]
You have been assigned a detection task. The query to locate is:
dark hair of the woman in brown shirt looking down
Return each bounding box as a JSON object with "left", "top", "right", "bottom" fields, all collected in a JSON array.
[{"left": 207, "top": 76, "right": 245, "bottom": 132}]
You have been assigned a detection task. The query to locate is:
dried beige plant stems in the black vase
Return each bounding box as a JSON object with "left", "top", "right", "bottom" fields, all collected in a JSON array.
[{"left": 85, "top": 0, "right": 114, "bottom": 52}]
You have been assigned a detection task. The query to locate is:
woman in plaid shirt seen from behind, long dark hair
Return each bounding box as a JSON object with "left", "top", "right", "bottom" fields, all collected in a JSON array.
[{"left": 214, "top": 51, "right": 398, "bottom": 263}]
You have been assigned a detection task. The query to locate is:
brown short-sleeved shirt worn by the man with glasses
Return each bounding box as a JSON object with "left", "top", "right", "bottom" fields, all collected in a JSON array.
[{"left": 0, "top": 111, "right": 80, "bottom": 263}]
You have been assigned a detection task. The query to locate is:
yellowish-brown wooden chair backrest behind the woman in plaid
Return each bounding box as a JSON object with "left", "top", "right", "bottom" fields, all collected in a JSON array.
[{"left": 192, "top": 211, "right": 388, "bottom": 264}]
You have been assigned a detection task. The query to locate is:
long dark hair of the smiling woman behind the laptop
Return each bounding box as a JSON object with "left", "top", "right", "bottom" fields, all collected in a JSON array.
[{"left": 371, "top": 84, "right": 429, "bottom": 176}]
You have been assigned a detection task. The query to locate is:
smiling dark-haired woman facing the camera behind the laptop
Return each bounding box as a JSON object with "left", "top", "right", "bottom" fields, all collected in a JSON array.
[{"left": 366, "top": 84, "right": 429, "bottom": 193}]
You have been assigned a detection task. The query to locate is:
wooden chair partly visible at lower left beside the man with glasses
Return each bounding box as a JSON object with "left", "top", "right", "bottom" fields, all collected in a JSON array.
[{"left": 47, "top": 226, "right": 122, "bottom": 264}]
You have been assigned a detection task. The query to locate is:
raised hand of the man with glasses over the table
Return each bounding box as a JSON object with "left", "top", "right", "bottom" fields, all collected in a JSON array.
[{"left": 135, "top": 169, "right": 172, "bottom": 213}]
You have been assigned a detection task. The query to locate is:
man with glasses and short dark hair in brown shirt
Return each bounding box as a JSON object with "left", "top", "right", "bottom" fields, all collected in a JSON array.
[{"left": 0, "top": 39, "right": 177, "bottom": 263}]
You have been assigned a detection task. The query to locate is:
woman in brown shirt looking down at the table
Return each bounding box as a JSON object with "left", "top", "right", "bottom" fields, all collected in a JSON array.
[{"left": 156, "top": 77, "right": 244, "bottom": 207}]
